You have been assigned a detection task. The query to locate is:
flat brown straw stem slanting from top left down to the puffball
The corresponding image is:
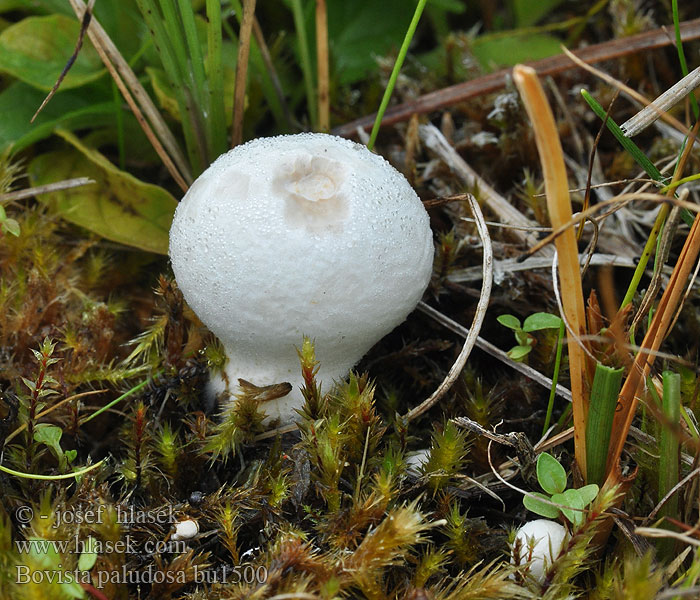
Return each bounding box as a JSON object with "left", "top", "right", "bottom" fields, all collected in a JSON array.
[{"left": 70, "top": 0, "right": 192, "bottom": 192}]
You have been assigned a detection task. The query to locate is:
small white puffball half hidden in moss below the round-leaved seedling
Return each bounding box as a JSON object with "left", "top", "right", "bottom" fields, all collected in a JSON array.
[{"left": 510, "top": 519, "right": 567, "bottom": 583}]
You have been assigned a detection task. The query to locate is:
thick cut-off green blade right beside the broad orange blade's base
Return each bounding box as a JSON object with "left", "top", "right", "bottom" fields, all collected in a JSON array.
[{"left": 586, "top": 363, "right": 624, "bottom": 485}]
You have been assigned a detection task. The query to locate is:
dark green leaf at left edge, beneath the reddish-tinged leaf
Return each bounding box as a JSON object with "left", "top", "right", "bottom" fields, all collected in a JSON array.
[{"left": 0, "top": 81, "right": 114, "bottom": 152}]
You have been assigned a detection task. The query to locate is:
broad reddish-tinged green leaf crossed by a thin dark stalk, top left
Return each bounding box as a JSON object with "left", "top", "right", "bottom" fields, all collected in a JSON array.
[{"left": 0, "top": 15, "right": 105, "bottom": 92}]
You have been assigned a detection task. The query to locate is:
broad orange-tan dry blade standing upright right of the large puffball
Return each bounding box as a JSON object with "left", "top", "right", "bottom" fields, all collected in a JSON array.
[{"left": 513, "top": 65, "right": 588, "bottom": 481}]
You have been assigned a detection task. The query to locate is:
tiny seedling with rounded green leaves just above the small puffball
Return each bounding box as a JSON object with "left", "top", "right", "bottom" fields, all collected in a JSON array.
[{"left": 523, "top": 452, "right": 599, "bottom": 527}]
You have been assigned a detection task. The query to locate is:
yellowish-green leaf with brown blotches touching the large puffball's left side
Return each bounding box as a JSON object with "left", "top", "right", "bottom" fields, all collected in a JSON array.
[{"left": 28, "top": 131, "right": 177, "bottom": 254}]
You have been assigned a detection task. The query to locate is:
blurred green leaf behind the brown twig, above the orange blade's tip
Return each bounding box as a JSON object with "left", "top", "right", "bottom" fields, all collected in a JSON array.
[{"left": 472, "top": 31, "right": 561, "bottom": 69}]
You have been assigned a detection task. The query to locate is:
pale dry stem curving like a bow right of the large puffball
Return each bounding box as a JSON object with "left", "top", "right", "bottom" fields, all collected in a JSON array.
[{"left": 404, "top": 197, "right": 493, "bottom": 422}]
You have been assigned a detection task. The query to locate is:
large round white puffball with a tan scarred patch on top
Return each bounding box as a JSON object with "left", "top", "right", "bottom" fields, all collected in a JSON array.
[{"left": 170, "top": 133, "right": 433, "bottom": 423}]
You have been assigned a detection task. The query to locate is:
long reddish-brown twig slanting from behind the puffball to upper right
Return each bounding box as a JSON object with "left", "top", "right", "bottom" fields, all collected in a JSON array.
[{"left": 333, "top": 19, "right": 700, "bottom": 137}]
